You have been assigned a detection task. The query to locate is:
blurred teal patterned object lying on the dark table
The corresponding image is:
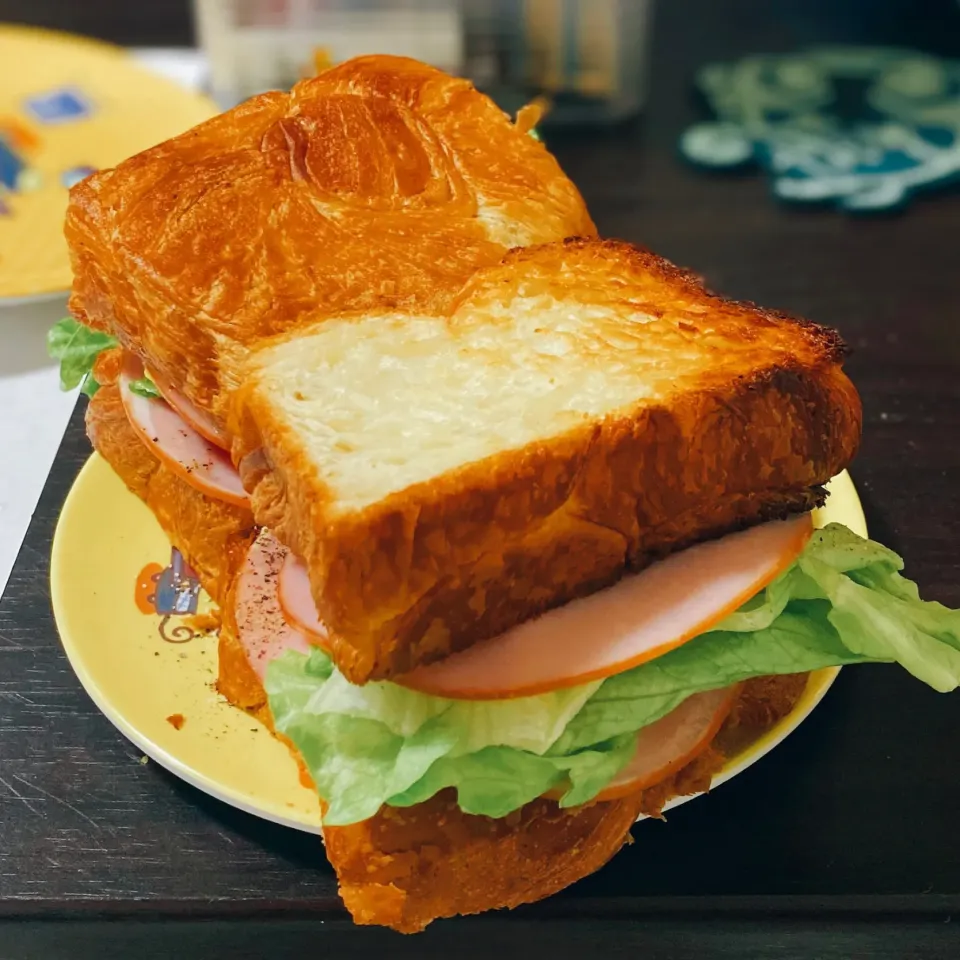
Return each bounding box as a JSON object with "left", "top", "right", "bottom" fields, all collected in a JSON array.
[{"left": 680, "top": 47, "right": 960, "bottom": 211}]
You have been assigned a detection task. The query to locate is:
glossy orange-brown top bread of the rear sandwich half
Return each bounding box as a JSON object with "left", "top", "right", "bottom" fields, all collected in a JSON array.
[{"left": 65, "top": 56, "right": 595, "bottom": 418}]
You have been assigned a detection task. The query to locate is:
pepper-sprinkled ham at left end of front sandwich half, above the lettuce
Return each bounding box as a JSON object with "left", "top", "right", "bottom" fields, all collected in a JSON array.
[{"left": 234, "top": 530, "right": 310, "bottom": 681}]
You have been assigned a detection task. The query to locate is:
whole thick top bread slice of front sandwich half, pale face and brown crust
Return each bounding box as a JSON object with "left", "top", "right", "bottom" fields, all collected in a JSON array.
[{"left": 232, "top": 240, "right": 861, "bottom": 683}]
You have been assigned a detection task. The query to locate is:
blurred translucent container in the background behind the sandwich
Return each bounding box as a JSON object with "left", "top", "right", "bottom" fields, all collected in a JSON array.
[{"left": 194, "top": 0, "right": 651, "bottom": 124}]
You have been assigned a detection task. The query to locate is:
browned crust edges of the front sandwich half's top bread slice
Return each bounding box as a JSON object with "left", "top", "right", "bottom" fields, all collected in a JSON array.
[{"left": 232, "top": 240, "right": 861, "bottom": 683}]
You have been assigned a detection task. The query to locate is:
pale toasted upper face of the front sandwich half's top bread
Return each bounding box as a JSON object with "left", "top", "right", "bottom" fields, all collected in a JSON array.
[{"left": 236, "top": 240, "right": 843, "bottom": 518}]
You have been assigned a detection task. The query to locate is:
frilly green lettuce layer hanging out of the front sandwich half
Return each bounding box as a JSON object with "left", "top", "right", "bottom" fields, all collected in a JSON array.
[{"left": 266, "top": 524, "right": 960, "bottom": 825}]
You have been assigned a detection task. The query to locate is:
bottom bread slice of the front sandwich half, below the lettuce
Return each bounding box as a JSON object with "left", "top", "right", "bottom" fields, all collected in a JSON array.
[{"left": 218, "top": 608, "right": 807, "bottom": 933}]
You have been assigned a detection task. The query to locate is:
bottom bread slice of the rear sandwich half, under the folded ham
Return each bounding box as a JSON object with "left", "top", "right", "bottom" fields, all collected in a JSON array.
[{"left": 86, "top": 350, "right": 256, "bottom": 605}]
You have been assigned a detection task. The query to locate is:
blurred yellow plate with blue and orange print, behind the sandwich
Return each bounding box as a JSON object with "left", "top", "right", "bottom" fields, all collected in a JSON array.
[{"left": 0, "top": 25, "right": 217, "bottom": 304}]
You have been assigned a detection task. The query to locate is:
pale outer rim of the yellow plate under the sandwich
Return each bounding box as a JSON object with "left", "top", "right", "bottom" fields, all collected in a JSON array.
[{"left": 49, "top": 452, "right": 867, "bottom": 834}]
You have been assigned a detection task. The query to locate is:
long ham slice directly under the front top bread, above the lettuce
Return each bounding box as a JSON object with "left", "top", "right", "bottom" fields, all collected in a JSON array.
[{"left": 396, "top": 514, "right": 813, "bottom": 700}]
